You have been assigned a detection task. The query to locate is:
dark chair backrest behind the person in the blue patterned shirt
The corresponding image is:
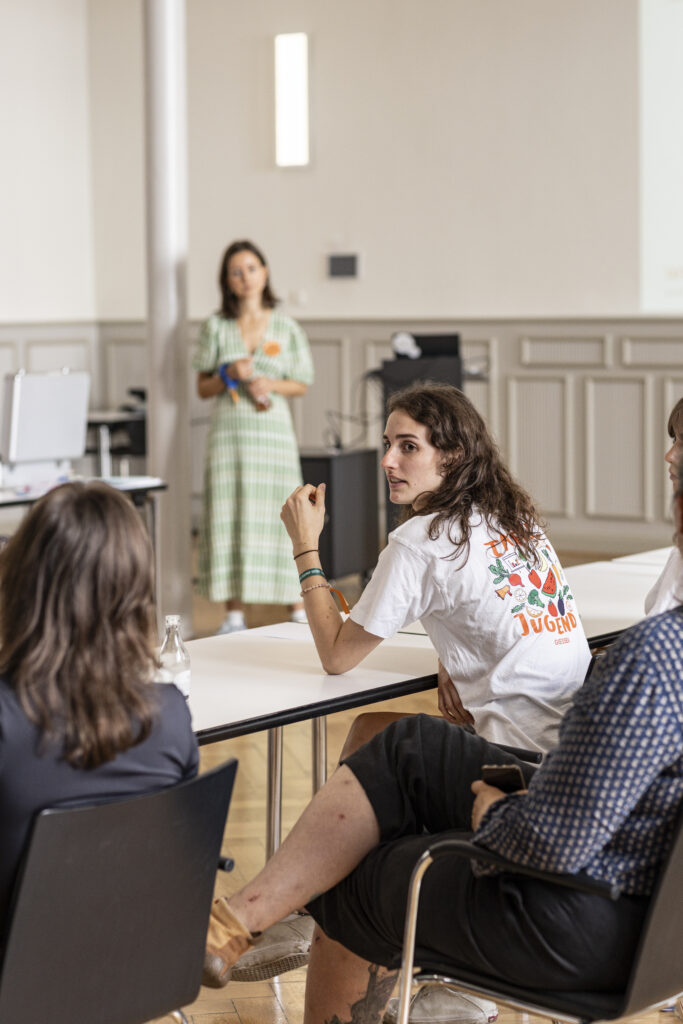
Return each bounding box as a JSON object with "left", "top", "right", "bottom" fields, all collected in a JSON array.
[{"left": 622, "top": 808, "right": 683, "bottom": 1017}]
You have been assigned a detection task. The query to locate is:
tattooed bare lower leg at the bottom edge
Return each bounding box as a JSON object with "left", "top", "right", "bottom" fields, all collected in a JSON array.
[{"left": 303, "top": 927, "right": 396, "bottom": 1024}]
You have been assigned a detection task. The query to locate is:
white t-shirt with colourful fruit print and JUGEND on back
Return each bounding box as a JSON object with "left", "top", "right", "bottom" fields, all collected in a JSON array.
[{"left": 351, "top": 514, "right": 590, "bottom": 751}]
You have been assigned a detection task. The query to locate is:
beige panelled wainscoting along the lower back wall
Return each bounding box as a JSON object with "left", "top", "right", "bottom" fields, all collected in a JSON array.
[{"left": 0, "top": 318, "right": 683, "bottom": 554}]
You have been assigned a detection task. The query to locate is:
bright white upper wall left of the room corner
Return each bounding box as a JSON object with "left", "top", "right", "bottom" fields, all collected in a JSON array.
[{"left": 0, "top": 0, "right": 95, "bottom": 323}]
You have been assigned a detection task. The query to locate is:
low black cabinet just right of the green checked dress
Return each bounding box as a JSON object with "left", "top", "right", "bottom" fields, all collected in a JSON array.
[{"left": 300, "top": 449, "right": 379, "bottom": 580}]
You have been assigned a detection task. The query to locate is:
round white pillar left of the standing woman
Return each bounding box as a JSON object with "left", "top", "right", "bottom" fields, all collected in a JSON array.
[{"left": 144, "top": 0, "right": 191, "bottom": 636}]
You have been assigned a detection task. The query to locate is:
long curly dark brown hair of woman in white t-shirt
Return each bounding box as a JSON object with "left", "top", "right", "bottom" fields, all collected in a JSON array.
[{"left": 387, "top": 382, "right": 544, "bottom": 559}]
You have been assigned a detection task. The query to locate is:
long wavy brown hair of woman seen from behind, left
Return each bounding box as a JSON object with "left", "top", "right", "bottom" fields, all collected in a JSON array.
[{"left": 0, "top": 482, "right": 157, "bottom": 768}]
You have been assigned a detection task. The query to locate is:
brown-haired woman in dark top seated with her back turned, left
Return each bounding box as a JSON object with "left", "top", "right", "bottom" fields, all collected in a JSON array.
[{"left": 0, "top": 482, "right": 198, "bottom": 928}]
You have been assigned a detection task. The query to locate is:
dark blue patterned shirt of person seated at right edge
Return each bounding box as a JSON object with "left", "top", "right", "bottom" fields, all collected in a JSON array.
[{"left": 472, "top": 605, "right": 683, "bottom": 895}]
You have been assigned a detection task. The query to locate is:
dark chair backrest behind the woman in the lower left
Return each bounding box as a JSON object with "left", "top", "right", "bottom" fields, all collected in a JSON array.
[{"left": 0, "top": 760, "right": 238, "bottom": 1024}]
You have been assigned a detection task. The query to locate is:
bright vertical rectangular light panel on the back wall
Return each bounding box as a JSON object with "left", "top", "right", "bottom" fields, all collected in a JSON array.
[{"left": 275, "top": 32, "right": 309, "bottom": 167}]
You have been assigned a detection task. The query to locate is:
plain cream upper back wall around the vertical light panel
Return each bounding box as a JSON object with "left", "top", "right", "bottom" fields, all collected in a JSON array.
[{"left": 83, "top": 0, "right": 639, "bottom": 319}]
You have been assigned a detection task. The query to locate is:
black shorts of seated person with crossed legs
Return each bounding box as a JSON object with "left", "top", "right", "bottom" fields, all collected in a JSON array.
[{"left": 309, "top": 715, "right": 648, "bottom": 991}]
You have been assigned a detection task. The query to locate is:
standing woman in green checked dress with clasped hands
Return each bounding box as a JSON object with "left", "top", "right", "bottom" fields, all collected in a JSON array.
[{"left": 194, "top": 241, "right": 313, "bottom": 633}]
